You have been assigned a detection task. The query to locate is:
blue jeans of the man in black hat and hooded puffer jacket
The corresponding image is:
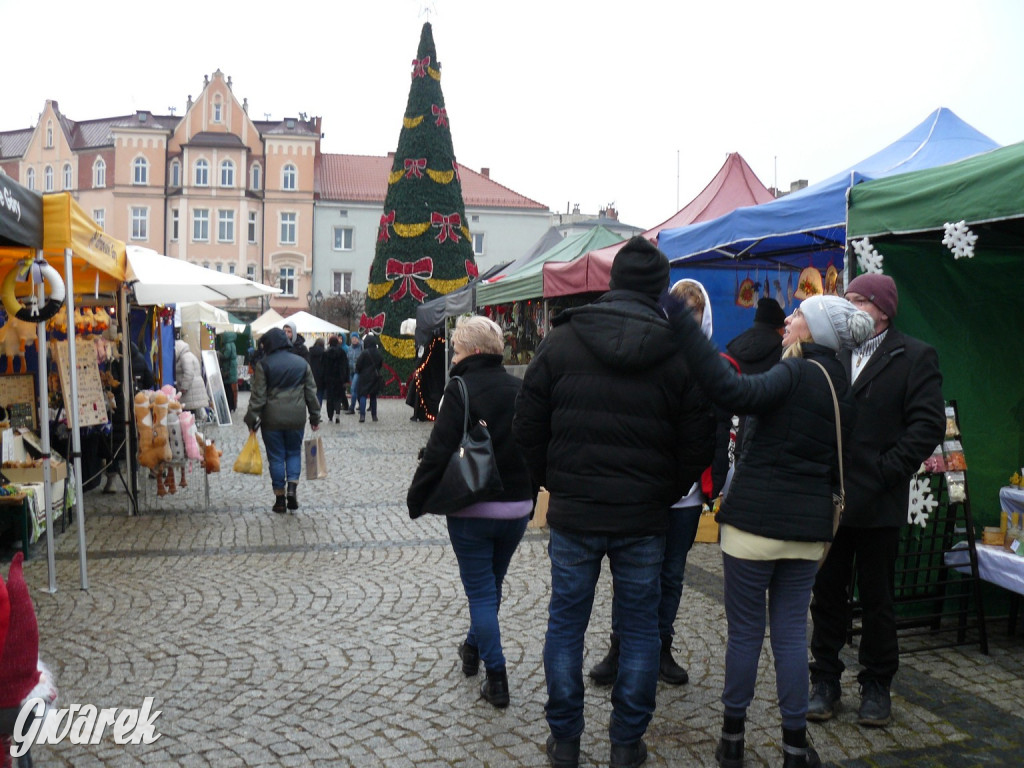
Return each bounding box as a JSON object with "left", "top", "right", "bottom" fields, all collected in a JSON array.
[{"left": 544, "top": 528, "right": 665, "bottom": 744}]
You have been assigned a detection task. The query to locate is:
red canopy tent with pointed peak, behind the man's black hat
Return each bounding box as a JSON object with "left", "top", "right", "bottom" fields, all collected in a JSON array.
[{"left": 544, "top": 152, "right": 774, "bottom": 298}]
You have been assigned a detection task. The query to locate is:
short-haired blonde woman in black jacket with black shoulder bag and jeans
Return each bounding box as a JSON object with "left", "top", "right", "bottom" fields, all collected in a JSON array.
[{"left": 406, "top": 315, "right": 536, "bottom": 709}]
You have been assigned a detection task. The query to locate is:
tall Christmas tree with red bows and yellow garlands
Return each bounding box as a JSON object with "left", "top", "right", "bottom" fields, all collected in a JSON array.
[{"left": 359, "top": 24, "right": 477, "bottom": 395}]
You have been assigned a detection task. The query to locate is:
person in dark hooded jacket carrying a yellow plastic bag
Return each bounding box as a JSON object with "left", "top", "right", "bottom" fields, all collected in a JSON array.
[{"left": 245, "top": 328, "right": 319, "bottom": 514}]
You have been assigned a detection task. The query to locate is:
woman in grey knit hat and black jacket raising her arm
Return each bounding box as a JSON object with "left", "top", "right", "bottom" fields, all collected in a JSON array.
[{"left": 668, "top": 296, "right": 872, "bottom": 768}]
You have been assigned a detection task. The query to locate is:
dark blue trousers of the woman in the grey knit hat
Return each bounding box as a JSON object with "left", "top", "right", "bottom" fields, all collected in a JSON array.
[{"left": 722, "top": 553, "right": 818, "bottom": 729}]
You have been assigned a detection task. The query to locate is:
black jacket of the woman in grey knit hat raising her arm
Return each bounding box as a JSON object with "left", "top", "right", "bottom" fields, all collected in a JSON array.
[{"left": 673, "top": 312, "right": 855, "bottom": 542}]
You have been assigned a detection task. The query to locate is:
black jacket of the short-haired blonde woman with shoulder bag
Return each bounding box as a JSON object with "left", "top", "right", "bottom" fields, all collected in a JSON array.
[{"left": 406, "top": 354, "right": 536, "bottom": 518}]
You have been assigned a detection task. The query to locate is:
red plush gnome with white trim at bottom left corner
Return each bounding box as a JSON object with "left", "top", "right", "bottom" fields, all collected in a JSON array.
[{"left": 0, "top": 552, "right": 57, "bottom": 765}]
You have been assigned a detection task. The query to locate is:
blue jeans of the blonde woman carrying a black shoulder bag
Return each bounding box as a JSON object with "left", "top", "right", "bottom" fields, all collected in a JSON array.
[{"left": 447, "top": 516, "right": 529, "bottom": 670}]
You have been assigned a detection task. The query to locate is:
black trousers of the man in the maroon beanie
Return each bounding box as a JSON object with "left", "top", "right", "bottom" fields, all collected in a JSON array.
[{"left": 811, "top": 525, "right": 900, "bottom": 687}]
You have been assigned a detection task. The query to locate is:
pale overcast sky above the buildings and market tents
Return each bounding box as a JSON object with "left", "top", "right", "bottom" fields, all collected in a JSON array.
[{"left": 0, "top": 0, "right": 1024, "bottom": 228}]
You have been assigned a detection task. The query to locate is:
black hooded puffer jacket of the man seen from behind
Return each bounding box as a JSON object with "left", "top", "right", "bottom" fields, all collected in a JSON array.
[{"left": 513, "top": 290, "right": 714, "bottom": 536}]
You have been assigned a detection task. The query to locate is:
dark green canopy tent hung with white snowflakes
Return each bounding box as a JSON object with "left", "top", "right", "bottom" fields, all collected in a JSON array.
[{"left": 847, "top": 143, "right": 1024, "bottom": 524}]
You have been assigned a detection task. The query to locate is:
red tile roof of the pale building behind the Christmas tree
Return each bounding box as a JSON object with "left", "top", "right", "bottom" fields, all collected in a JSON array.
[{"left": 315, "top": 155, "right": 548, "bottom": 210}]
